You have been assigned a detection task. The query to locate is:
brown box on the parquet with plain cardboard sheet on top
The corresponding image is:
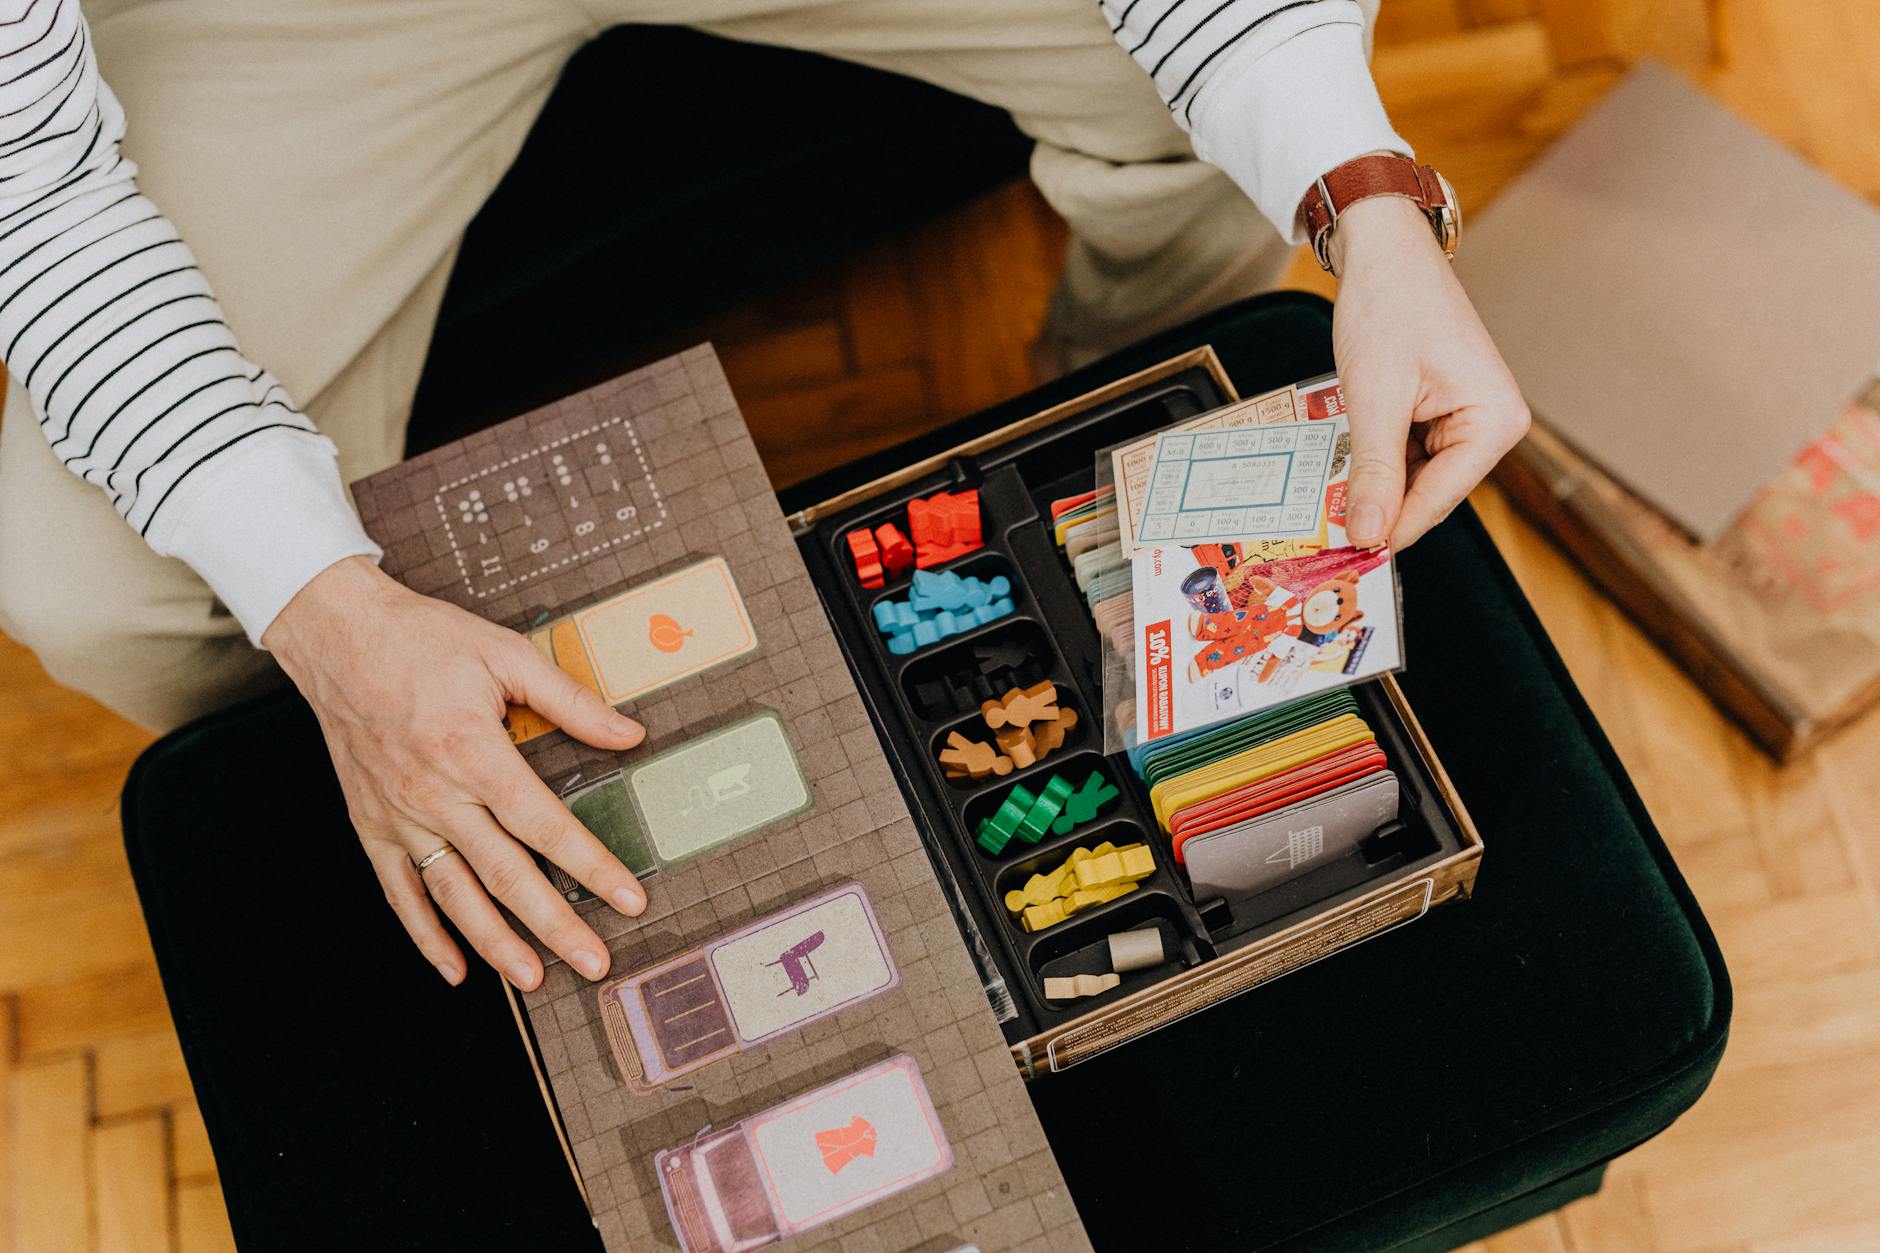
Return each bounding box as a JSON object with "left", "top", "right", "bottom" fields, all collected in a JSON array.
[{"left": 1455, "top": 62, "right": 1880, "bottom": 760}]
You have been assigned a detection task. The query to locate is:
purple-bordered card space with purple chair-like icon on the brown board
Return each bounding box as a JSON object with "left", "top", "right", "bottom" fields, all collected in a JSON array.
[{"left": 600, "top": 882, "right": 901, "bottom": 1093}]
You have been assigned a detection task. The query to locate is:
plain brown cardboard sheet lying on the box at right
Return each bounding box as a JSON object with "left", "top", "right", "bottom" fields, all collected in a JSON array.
[{"left": 1455, "top": 62, "right": 1880, "bottom": 542}]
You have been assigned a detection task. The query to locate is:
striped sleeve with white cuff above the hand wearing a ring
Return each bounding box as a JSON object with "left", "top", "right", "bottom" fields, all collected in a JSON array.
[{"left": 0, "top": 0, "right": 378, "bottom": 643}]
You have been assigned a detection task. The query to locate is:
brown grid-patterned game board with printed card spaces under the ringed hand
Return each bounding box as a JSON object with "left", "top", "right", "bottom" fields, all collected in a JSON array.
[{"left": 353, "top": 348, "right": 1089, "bottom": 1249}]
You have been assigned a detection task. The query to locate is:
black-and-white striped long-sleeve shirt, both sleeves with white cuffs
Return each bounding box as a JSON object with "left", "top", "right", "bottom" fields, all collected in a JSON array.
[{"left": 0, "top": 0, "right": 1404, "bottom": 643}]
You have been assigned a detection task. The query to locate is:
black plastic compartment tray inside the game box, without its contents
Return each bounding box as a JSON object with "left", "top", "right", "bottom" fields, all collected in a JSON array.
[{"left": 797, "top": 367, "right": 1459, "bottom": 1042}]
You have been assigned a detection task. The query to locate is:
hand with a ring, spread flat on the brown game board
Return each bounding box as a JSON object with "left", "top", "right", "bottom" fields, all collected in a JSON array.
[{"left": 263, "top": 557, "right": 647, "bottom": 990}]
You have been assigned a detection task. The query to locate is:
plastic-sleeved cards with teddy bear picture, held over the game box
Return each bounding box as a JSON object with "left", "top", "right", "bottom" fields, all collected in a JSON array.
[{"left": 1051, "top": 376, "right": 1402, "bottom": 752}]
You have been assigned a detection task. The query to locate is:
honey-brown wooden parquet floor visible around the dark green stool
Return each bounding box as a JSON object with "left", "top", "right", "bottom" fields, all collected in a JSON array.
[{"left": 0, "top": 0, "right": 1880, "bottom": 1253}]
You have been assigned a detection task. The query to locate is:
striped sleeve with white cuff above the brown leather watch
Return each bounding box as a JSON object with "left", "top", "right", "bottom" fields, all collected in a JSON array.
[{"left": 1098, "top": 0, "right": 1410, "bottom": 243}]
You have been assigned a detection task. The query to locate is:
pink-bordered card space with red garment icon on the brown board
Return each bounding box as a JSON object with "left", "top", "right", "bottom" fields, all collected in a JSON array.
[{"left": 652, "top": 1054, "right": 953, "bottom": 1253}]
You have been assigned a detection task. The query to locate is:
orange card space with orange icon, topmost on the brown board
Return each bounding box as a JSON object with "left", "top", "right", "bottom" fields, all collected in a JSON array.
[{"left": 506, "top": 557, "right": 758, "bottom": 743}]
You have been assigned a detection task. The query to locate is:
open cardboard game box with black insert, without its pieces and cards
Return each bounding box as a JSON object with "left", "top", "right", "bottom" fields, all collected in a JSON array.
[{"left": 790, "top": 348, "right": 1481, "bottom": 1080}]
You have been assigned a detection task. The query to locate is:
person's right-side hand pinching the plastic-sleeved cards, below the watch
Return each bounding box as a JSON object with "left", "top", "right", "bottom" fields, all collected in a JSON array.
[{"left": 1331, "top": 196, "right": 1528, "bottom": 549}]
